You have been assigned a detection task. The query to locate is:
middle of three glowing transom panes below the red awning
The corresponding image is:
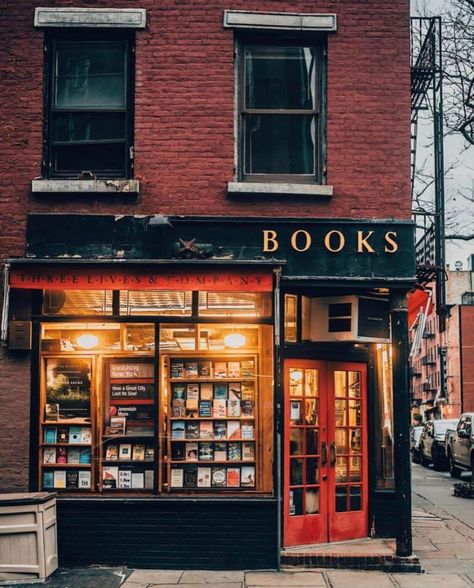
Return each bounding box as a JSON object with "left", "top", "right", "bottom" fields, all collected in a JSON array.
[{"left": 120, "top": 290, "right": 192, "bottom": 316}]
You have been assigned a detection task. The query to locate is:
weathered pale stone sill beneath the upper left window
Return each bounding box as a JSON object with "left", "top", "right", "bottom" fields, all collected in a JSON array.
[{"left": 31, "top": 180, "right": 140, "bottom": 194}]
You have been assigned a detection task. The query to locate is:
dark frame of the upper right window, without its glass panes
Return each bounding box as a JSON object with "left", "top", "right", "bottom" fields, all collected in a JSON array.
[{"left": 235, "top": 33, "right": 327, "bottom": 185}]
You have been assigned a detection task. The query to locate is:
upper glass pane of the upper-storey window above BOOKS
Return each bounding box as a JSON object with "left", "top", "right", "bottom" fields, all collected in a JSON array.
[{"left": 244, "top": 46, "right": 316, "bottom": 109}]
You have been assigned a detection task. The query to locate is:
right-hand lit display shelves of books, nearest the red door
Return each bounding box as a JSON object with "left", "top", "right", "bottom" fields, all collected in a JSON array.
[{"left": 167, "top": 357, "right": 257, "bottom": 491}]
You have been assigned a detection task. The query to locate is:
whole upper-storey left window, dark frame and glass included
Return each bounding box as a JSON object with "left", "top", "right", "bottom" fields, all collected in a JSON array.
[{"left": 44, "top": 30, "right": 133, "bottom": 179}]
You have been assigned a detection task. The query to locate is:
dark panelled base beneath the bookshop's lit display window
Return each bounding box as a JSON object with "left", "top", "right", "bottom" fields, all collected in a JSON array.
[{"left": 57, "top": 497, "right": 278, "bottom": 570}]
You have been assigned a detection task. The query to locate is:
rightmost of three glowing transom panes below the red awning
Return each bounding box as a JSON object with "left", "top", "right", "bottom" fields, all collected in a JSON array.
[{"left": 199, "top": 292, "right": 272, "bottom": 318}]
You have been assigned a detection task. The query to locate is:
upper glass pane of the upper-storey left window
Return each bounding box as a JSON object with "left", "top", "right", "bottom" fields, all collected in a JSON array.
[{"left": 54, "top": 43, "right": 126, "bottom": 108}]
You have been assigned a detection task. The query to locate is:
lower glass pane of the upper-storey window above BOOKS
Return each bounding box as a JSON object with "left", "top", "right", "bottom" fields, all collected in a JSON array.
[{"left": 244, "top": 114, "right": 316, "bottom": 175}]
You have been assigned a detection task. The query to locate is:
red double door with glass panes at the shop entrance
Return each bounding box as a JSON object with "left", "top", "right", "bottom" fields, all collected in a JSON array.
[{"left": 284, "top": 360, "right": 368, "bottom": 546}]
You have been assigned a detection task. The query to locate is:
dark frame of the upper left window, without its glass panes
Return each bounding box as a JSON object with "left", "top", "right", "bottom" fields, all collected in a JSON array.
[{"left": 42, "top": 28, "right": 135, "bottom": 180}]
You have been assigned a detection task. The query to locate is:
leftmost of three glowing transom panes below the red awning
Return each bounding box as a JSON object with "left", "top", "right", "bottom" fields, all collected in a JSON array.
[{"left": 42, "top": 290, "right": 112, "bottom": 316}]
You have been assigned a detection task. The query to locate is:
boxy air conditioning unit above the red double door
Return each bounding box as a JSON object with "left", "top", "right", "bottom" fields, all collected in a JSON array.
[{"left": 310, "top": 296, "right": 390, "bottom": 343}]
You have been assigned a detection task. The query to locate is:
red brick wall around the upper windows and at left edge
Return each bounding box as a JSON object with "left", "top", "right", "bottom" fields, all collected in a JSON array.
[{"left": 0, "top": 0, "right": 410, "bottom": 488}]
